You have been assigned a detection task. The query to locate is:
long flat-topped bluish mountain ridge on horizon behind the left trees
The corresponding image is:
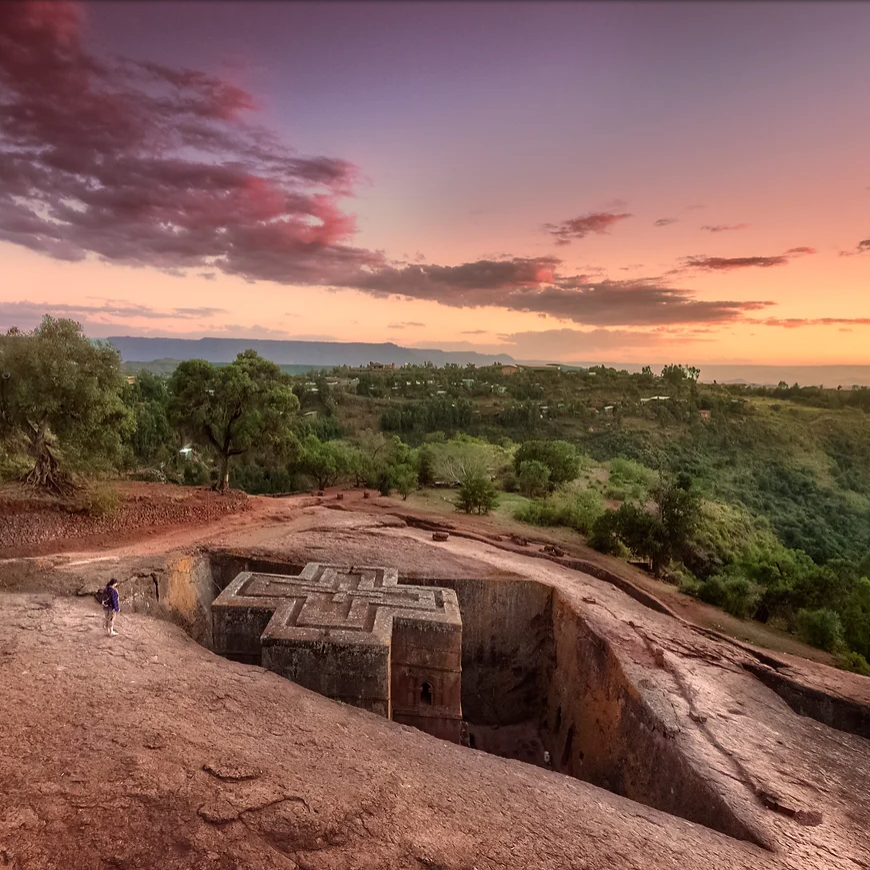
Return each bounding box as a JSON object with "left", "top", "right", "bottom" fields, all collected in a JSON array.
[{"left": 107, "top": 335, "right": 515, "bottom": 368}]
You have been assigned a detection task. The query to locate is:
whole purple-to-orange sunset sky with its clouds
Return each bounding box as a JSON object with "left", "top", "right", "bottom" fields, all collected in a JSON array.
[{"left": 0, "top": 0, "right": 870, "bottom": 365}]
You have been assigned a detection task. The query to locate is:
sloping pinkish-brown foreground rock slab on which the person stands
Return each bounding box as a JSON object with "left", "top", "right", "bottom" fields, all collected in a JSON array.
[{"left": 0, "top": 594, "right": 784, "bottom": 870}]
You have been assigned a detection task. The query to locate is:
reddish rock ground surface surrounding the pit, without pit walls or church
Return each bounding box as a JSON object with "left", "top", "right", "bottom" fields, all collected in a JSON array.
[{"left": 0, "top": 488, "right": 870, "bottom": 870}]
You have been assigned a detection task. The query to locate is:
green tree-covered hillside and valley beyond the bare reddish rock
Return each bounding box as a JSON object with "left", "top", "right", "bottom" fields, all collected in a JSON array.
[{"left": 0, "top": 318, "right": 870, "bottom": 670}]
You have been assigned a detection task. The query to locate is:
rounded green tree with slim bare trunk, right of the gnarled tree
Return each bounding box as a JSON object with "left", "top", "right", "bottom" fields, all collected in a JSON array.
[{"left": 169, "top": 350, "right": 299, "bottom": 491}]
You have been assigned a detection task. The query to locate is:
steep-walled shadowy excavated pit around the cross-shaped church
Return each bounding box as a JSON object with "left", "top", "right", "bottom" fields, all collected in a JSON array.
[{"left": 140, "top": 551, "right": 766, "bottom": 846}]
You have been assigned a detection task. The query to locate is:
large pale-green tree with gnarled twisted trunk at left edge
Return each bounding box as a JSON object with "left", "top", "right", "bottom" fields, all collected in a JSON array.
[{"left": 0, "top": 316, "right": 132, "bottom": 494}]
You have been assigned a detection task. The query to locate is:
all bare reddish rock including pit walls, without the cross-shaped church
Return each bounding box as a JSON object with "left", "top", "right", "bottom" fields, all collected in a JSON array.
[{"left": 0, "top": 500, "right": 870, "bottom": 870}]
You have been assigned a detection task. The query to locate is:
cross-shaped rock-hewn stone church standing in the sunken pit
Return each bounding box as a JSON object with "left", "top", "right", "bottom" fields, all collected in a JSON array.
[{"left": 212, "top": 562, "right": 462, "bottom": 743}]
